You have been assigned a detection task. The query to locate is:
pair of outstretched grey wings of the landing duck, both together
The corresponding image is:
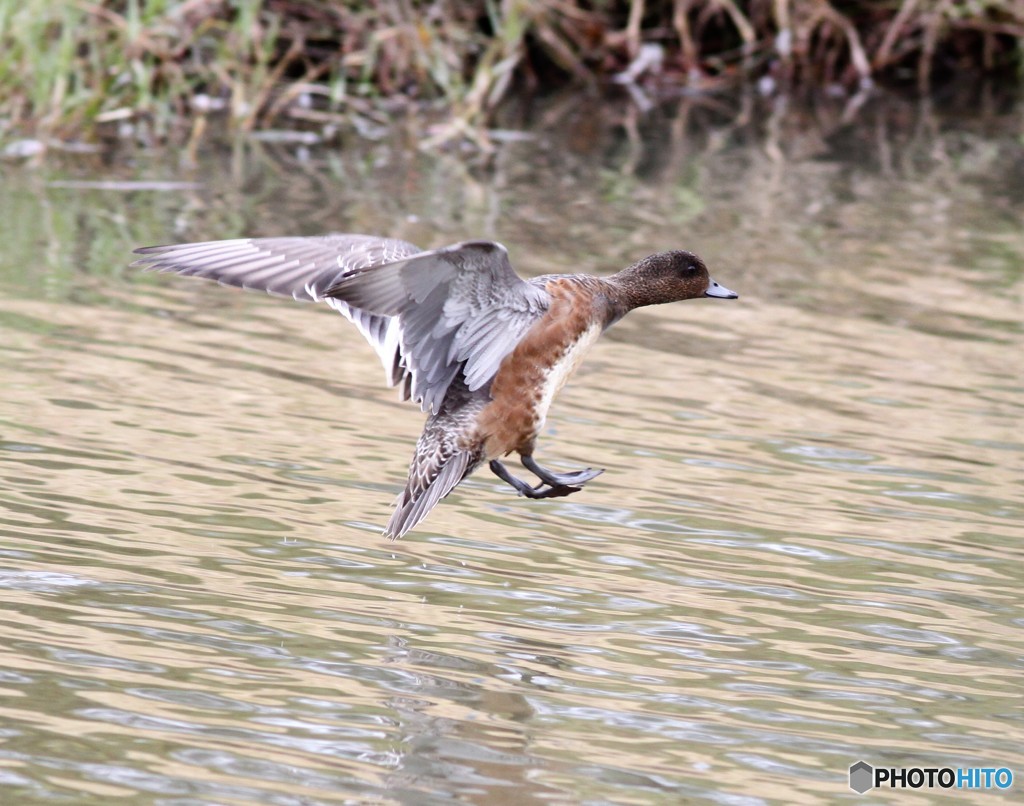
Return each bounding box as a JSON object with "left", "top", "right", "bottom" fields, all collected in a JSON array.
[{"left": 132, "top": 235, "right": 550, "bottom": 412}]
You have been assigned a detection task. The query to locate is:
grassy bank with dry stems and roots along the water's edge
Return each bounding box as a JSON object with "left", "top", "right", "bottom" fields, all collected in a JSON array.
[{"left": 0, "top": 0, "right": 1024, "bottom": 146}]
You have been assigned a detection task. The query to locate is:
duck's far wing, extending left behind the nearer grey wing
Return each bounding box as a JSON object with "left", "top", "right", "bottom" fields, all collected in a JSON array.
[{"left": 132, "top": 235, "right": 422, "bottom": 387}]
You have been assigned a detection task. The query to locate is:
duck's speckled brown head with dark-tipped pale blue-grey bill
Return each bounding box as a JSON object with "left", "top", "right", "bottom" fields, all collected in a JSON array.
[{"left": 611, "top": 250, "right": 739, "bottom": 308}]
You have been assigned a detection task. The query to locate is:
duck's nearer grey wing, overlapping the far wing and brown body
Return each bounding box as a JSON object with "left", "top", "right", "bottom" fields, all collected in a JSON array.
[{"left": 325, "top": 241, "right": 551, "bottom": 412}]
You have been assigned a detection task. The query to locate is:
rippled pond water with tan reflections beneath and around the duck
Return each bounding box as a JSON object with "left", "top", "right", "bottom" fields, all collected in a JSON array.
[{"left": 0, "top": 93, "right": 1024, "bottom": 804}]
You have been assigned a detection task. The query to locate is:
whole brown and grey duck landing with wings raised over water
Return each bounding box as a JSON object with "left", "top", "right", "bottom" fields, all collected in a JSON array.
[{"left": 132, "top": 234, "right": 738, "bottom": 540}]
